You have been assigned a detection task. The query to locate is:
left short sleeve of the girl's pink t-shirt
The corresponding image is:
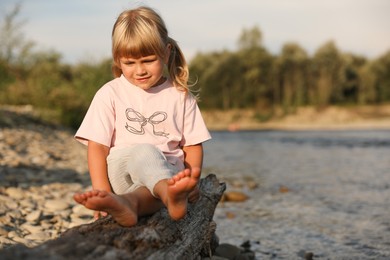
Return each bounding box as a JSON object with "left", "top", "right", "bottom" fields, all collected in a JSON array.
[{"left": 75, "top": 88, "right": 115, "bottom": 147}]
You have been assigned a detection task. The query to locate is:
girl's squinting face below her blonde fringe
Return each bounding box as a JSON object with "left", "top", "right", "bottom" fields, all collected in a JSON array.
[{"left": 119, "top": 55, "right": 165, "bottom": 90}]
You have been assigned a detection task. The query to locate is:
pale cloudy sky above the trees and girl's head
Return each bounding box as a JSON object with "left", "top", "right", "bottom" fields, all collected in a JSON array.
[{"left": 0, "top": 0, "right": 390, "bottom": 63}]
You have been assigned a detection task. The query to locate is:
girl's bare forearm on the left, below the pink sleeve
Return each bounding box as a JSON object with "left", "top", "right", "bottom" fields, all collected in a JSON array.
[{"left": 88, "top": 141, "right": 111, "bottom": 192}]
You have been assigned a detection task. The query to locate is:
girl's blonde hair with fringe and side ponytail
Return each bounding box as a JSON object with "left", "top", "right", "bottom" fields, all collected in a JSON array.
[{"left": 112, "top": 6, "right": 189, "bottom": 92}]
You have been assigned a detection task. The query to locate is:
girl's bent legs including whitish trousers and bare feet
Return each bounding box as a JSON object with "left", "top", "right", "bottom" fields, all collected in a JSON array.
[{"left": 74, "top": 144, "right": 200, "bottom": 226}]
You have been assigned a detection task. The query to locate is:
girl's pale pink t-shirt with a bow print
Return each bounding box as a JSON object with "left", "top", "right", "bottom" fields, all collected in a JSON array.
[{"left": 75, "top": 75, "right": 211, "bottom": 165}]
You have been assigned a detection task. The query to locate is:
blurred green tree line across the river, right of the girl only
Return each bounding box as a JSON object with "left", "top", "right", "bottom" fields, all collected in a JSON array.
[{"left": 190, "top": 26, "right": 390, "bottom": 116}]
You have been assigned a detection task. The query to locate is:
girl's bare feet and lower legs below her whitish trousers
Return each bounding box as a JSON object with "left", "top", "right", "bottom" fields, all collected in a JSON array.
[{"left": 73, "top": 168, "right": 200, "bottom": 224}]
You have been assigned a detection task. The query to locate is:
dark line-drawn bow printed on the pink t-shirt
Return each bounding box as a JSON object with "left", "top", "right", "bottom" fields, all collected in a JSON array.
[{"left": 125, "top": 108, "right": 169, "bottom": 137}]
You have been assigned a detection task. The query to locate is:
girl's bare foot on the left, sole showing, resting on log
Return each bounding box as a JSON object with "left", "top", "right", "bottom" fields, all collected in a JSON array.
[{"left": 73, "top": 190, "right": 138, "bottom": 227}]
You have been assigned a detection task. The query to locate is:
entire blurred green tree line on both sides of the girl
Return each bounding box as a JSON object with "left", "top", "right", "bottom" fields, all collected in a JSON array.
[{"left": 0, "top": 5, "right": 390, "bottom": 127}]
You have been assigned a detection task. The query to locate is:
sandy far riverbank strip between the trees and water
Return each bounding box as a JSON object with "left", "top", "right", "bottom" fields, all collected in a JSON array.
[{"left": 202, "top": 105, "right": 390, "bottom": 131}]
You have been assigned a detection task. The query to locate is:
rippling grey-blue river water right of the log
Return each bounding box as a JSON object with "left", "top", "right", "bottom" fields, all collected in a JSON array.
[{"left": 203, "top": 130, "right": 390, "bottom": 259}]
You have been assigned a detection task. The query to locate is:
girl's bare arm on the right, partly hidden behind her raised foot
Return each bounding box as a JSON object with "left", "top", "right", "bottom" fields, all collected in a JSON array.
[{"left": 183, "top": 144, "right": 203, "bottom": 202}]
